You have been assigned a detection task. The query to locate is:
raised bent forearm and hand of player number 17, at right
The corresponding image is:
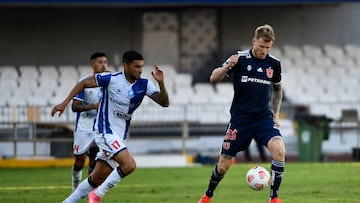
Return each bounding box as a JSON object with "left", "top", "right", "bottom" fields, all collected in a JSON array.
[{"left": 150, "top": 64, "right": 170, "bottom": 107}]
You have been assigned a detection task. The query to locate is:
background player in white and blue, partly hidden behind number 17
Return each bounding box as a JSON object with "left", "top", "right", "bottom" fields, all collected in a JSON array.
[{"left": 71, "top": 52, "right": 107, "bottom": 191}]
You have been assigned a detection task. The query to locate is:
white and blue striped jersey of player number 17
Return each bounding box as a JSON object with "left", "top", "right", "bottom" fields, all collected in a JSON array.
[{"left": 95, "top": 72, "right": 157, "bottom": 139}]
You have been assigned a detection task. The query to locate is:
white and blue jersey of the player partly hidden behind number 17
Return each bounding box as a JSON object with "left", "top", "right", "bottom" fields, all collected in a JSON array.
[{"left": 73, "top": 74, "right": 102, "bottom": 132}]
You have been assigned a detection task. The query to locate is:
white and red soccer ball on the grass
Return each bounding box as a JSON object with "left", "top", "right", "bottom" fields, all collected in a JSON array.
[{"left": 246, "top": 166, "right": 270, "bottom": 190}]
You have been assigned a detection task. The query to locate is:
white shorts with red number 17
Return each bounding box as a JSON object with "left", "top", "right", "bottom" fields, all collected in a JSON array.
[{"left": 95, "top": 133, "right": 127, "bottom": 168}]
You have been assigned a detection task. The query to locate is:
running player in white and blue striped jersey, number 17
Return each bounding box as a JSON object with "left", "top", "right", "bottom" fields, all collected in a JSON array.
[{"left": 51, "top": 51, "right": 169, "bottom": 203}]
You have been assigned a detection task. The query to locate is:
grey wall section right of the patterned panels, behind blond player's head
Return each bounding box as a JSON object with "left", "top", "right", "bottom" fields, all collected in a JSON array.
[{"left": 221, "top": 3, "right": 360, "bottom": 55}]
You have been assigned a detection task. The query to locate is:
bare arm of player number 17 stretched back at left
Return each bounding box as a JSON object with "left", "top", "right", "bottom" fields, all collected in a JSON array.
[{"left": 51, "top": 75, "right": 97, "bottom": 117}]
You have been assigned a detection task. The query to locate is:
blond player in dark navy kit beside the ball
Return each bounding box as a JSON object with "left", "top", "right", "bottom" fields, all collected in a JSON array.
[{"left": 199, "top": 24, "right": 285, "bottom": 203}]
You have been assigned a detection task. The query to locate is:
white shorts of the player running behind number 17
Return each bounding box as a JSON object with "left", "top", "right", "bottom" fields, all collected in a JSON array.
[{"left": 73, "top": 129, "right": 95, "bottom": 155}]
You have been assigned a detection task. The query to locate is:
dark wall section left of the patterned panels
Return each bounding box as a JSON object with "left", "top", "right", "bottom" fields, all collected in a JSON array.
[{"left": 0, "top": 8, "right": 142, "bottom": 66}]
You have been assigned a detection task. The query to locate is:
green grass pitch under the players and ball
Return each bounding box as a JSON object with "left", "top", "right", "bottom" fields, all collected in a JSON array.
[{"left": 0, "top": 162, "right": 360, "bottom": 203}]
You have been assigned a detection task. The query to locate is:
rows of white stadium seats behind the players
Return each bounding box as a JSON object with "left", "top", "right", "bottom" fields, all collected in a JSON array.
[{"left": 0, "top": 45, "right": 360, "bottom": 122}]
